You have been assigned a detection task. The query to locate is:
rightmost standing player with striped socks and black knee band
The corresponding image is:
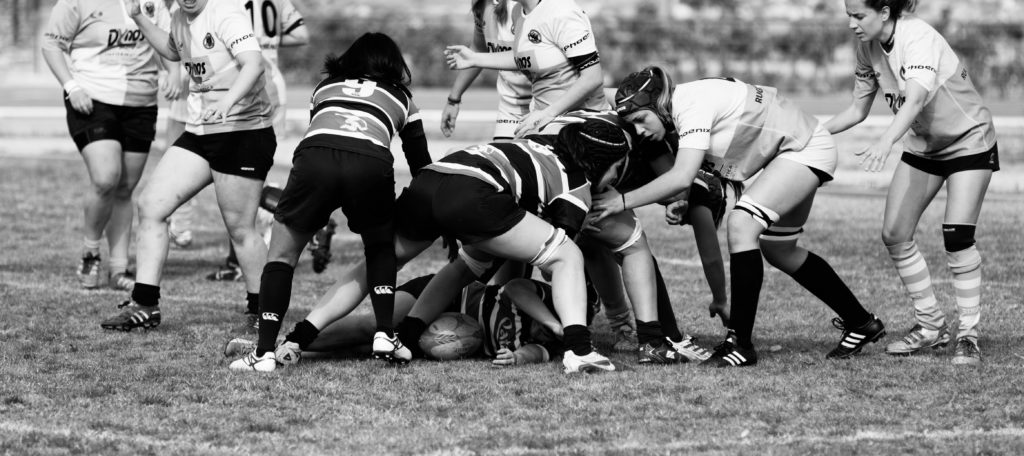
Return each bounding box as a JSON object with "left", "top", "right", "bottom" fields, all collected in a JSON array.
[{"left": 825, "top": 0, "right": 999, "bottom": 364}]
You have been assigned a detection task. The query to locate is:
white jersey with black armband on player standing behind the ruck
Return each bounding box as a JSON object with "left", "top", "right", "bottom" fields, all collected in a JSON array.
[{"left": 513, "top": 0, "right": 609, "bottom": 114}]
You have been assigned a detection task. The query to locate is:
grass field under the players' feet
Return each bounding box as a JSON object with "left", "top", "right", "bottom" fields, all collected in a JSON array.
[{"left": 0, "top": 149, "right": 1024, "bottom": 455}]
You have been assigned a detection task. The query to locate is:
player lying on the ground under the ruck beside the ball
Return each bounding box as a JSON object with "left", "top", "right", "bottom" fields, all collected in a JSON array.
[{"left": 224, "top": 275, "right": 599, "bottom": 366}]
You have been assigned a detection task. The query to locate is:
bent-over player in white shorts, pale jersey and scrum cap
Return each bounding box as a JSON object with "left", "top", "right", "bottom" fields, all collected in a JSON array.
[{"left": 594, "top": 67, "right": 885, "bottom": 367}]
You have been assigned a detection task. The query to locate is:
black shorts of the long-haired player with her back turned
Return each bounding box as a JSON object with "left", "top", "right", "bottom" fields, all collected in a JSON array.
[{"left": 274, "top": 147, "right": 394, "bottom": 232}]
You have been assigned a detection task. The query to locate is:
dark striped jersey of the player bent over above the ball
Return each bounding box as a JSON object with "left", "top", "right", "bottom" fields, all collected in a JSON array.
[{"left": 426, "top": 135, "right": 591, "bottom": 235}]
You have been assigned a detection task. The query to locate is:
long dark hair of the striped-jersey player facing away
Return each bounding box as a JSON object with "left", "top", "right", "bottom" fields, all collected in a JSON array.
[{"left": 324, "top": 32, "right": 413, "bottom": 87}]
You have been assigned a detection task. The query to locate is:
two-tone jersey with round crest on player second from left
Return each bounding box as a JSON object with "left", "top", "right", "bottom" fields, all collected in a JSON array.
[{"left": 170, "top": 1, "right": 273, "bottom": 135}]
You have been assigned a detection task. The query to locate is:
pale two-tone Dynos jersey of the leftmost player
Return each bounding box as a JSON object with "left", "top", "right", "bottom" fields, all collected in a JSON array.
[{"left": 42, "top": 0, "right": 170, "bottom": 107}]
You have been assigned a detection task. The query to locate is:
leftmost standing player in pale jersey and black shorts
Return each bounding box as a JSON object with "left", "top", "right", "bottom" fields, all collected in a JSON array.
[{"left": 42, "top": 0, "right": 177, "bottom": 290}]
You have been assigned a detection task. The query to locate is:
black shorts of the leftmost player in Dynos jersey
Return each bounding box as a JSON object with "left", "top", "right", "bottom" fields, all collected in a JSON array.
[{"left": 65, "top": 98, "right": 157, "bottom": 150}]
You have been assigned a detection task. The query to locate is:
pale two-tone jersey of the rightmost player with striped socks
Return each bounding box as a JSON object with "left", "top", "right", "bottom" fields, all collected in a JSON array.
[{"left": 853, "top": 15, "right": 995, "bottom": 160}]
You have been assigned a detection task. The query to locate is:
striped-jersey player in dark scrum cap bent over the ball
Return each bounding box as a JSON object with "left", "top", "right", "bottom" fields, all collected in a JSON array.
[{"left": 232, "top": 115, "right": 629, "bottom": 372}]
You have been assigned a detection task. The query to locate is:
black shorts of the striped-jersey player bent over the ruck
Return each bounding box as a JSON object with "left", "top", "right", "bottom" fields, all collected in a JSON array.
[{"left": 395, "top": 169, "right": 526, "bottom": 244}]
